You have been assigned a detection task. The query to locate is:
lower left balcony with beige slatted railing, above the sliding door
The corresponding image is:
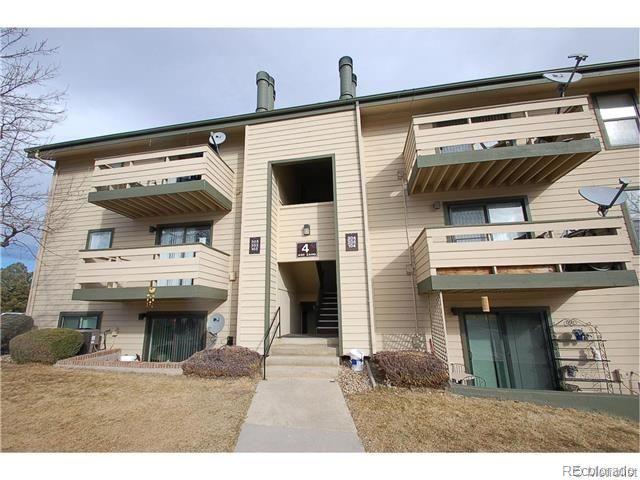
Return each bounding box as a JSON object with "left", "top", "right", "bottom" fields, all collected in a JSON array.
[{"left": 72, "top": 243, "right": 229, "bottom": 301}]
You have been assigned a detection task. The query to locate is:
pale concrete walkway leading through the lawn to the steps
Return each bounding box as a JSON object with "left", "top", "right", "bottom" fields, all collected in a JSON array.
[{"left": 236, "top": 378, "right": 364, "bottom": 452}]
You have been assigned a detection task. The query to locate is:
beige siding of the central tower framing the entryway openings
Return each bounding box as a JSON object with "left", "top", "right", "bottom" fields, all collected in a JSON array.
[{"left": 238, "top": 111, "right": 370, "bottom": 353}]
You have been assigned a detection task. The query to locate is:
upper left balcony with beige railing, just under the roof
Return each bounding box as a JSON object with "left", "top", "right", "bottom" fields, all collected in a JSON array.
[{"left": 89, "top": 145, "right": 234, "bottom": 218}]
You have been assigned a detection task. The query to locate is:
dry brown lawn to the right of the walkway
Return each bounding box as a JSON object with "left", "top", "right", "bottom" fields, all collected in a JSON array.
[{"left": 347, "top": 387, "right": 640, "bottom": 452}]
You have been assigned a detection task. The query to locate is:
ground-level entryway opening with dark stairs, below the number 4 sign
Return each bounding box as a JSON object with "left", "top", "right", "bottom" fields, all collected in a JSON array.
[{"left": 278, "top": 261, "right": 339, "bottom": 337}]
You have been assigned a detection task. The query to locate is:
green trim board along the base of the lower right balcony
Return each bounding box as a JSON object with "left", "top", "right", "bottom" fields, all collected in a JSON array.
[{"left": 418, "top": 270, "right": 638, "bottom": 293}]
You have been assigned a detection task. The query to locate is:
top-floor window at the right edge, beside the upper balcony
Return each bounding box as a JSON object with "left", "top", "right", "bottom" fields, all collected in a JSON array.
[{"left": 595, "top": 92, "right": 640, "bottom": 148}]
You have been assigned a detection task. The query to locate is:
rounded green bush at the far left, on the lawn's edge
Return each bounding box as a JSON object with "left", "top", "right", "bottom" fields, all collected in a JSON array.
[{"left": 9, "top": 328, "right": 84, "bottom": 364}]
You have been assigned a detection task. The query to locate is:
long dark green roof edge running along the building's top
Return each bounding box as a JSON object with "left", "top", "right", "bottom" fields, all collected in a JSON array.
[{"left": 26, "top": 59, "right": 640, "bottom": 155}]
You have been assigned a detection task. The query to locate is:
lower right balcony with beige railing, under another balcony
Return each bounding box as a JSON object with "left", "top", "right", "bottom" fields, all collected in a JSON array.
[{"left": 412, "top": 217, "right": 638, "bottom": 293}]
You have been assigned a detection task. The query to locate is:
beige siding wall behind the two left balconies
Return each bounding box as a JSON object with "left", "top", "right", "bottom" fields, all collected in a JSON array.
[{"left": 30, "top": 139, "right": 243, "bottom": 354}]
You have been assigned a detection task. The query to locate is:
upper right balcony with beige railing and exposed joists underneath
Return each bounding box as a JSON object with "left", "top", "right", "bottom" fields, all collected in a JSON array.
[{"left": 403, "top": 96, "right": 601, "bottom": 194}]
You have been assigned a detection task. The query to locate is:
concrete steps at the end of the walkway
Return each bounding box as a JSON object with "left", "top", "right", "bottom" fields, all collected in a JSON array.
[{"left": 267, "top": 335, "right": 340, "bottom": 380}]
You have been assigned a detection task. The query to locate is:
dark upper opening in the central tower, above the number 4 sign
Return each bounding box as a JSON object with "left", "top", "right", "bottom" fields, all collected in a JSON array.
[{"left": 273, "top": 158, "right": 333, "bottom": 205}]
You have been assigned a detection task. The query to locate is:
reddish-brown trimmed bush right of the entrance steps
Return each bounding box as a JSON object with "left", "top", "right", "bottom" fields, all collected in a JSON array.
[{"left": 373, "top": 351, "right": 449, "bottom": 388}]
